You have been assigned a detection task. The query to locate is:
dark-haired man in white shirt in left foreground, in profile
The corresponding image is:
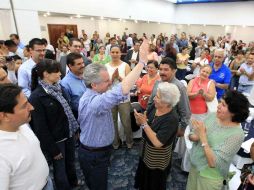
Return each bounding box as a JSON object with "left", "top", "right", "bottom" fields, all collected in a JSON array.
[{"left": 0, "top": 84, "right": 53, "bottom": 190}]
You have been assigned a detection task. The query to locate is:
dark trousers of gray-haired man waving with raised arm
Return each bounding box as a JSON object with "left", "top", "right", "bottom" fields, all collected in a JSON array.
[{"left": 78, "top": 147, "right": 111, "bottom": 190}]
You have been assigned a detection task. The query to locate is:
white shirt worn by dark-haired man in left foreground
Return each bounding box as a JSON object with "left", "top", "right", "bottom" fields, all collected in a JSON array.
[{"left": 0, "top": 124, "right": 49, "bottom": 190}]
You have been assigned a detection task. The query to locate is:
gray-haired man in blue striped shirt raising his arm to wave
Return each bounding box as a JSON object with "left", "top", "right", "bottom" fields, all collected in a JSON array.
[{"left": 78, "top": 59, "right": 144, "bottom": 190}]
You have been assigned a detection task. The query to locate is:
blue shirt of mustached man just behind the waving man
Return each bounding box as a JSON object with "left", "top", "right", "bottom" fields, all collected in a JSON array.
[{"left": 61, "top": 71, "right": 86, "bottom": 111}]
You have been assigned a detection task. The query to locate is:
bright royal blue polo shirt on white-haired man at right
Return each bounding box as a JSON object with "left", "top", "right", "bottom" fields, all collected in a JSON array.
[{"left": 209, "top": 63, "right": 231, "bottom": 100}]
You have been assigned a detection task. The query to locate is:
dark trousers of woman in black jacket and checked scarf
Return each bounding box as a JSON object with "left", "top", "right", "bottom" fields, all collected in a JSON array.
[{"left": 53, "top": 137, "right": 78, "bottom": 190}]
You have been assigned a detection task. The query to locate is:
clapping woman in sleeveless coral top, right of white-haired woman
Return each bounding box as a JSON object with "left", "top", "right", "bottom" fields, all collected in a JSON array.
[{"left": 187, "top": 65, "right": 216, "bottom": 119}]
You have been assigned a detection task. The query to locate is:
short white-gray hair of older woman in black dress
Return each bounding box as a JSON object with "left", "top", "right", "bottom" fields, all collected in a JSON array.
[{"left": 158, "top": 82, "right": 181, "bottom": 108}]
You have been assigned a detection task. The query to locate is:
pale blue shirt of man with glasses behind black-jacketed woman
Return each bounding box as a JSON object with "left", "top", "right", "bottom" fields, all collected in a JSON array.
[{"left": 18, "top": 58, "right": 36, "bottom": 98}]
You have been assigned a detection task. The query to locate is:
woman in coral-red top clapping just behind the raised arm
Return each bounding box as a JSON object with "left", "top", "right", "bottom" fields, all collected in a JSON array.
[{"left": 137, "top": 60, "right": 160, "bottom": 110}]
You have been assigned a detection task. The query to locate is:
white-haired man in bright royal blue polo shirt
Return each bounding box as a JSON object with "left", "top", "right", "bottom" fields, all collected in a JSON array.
[{"left": 209, "top": 49, "right": 231, "bottom": 100}]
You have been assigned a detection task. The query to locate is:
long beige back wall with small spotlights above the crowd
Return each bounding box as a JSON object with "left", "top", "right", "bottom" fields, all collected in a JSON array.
[{"left": 39, "top": 16, "right": 254, "bottom": 42}]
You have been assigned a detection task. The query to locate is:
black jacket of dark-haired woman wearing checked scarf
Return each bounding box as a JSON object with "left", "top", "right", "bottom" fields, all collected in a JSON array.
[{"left": 29, "top": 85, "right": 69, "bottom": 157}]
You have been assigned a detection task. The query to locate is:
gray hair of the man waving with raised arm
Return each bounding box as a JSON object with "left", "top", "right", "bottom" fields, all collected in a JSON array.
[{"left": 83, "top": 63, "right": 107, "bottom": 88}]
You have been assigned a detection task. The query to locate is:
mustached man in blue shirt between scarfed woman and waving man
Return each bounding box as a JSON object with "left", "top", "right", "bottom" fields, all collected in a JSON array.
[{"left": 61, "top": 53, "right": 86, "bottom": 118}]
